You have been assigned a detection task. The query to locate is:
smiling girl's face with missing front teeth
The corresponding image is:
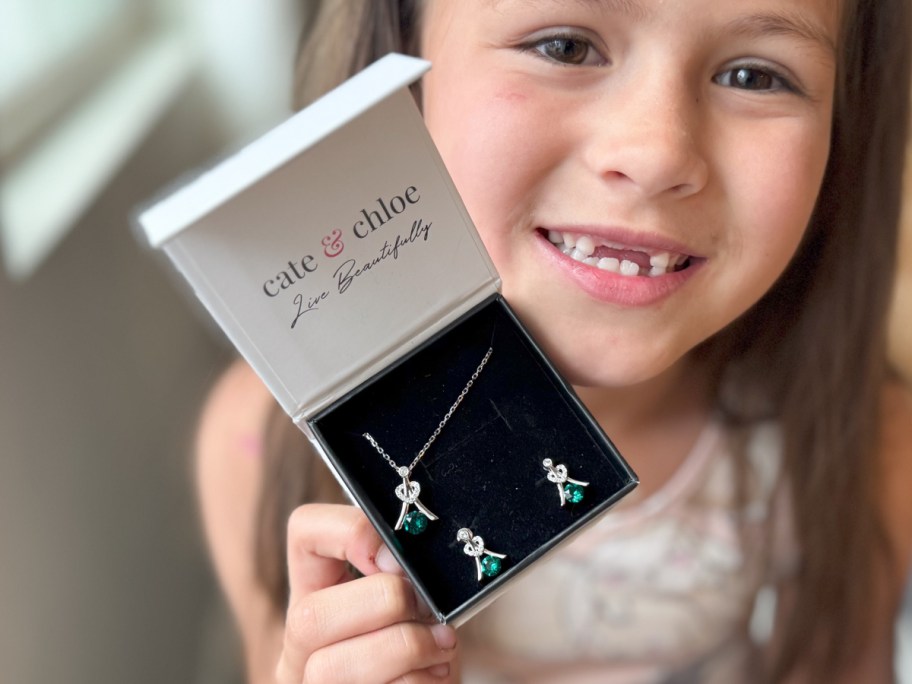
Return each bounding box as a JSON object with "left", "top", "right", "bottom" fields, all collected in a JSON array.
[{"left": 423, "top": 0, "right": 839, "bottom": 387}]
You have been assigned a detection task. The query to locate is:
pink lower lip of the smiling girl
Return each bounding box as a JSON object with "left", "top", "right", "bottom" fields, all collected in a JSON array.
[{"left": 538, "top": 233, "right": 705, "bottom": 307}]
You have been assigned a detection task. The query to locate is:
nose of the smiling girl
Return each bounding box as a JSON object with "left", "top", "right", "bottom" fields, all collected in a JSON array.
[{"left": 585, "top": 65, "right": 709, "bottom": 197}]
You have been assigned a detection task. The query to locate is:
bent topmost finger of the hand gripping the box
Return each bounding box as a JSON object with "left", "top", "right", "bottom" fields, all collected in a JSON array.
[{"left": 288, "top": 504, "right": 390, "bottom": 598}]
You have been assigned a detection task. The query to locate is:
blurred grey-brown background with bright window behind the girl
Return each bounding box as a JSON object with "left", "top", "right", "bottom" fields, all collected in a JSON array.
[{"left": 0, "top": 0, "right": 912, "bottom": 684}]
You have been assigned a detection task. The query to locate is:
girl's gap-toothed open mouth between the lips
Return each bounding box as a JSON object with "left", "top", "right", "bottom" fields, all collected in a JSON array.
[{"left": 542, "top": 230, "right": 692, "bottom": 278}]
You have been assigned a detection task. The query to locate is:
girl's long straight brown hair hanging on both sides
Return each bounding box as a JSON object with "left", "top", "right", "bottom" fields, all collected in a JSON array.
[{"left": 257, "top": 0, "right": 912, "bottom": 681}]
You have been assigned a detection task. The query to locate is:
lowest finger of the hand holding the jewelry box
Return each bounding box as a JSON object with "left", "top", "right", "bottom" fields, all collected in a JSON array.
[{"left": 304, "top": 622, "right": 456, "bottom": 684}]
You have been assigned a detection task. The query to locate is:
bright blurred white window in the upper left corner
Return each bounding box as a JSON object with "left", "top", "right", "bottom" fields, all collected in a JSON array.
[{"left": 0, "top": 0, "right": 301, "bottom": 280}]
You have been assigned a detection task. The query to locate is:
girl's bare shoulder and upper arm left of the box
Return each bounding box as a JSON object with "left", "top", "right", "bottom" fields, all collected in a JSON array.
[{"left": 196, "top": 361, "right": 281, "bottom": 681}]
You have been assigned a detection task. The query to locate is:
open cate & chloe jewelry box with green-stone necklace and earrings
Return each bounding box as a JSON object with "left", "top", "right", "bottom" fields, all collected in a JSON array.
[{"left": 138, "top": 55, "right": 637, "bottom": 625}]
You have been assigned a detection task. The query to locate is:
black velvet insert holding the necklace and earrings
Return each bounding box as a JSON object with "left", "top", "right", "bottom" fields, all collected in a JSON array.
[{"left": 310, "top": 296, "right": 636, "bottom": 620}]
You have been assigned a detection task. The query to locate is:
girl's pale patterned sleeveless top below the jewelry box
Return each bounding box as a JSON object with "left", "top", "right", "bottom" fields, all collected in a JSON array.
[{"left": 460, "top": 421, "right": 796, "bottom": 684}]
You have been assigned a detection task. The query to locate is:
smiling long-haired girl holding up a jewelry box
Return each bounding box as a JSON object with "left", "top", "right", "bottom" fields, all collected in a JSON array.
[{"left": 198, "top": 0, "right": 912, "bottom": 684}]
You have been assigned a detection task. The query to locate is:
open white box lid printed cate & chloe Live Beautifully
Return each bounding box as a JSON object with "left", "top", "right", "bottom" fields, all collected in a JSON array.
[{"left": 139, "top": 54, "right": 499, "bottom": 420}]
